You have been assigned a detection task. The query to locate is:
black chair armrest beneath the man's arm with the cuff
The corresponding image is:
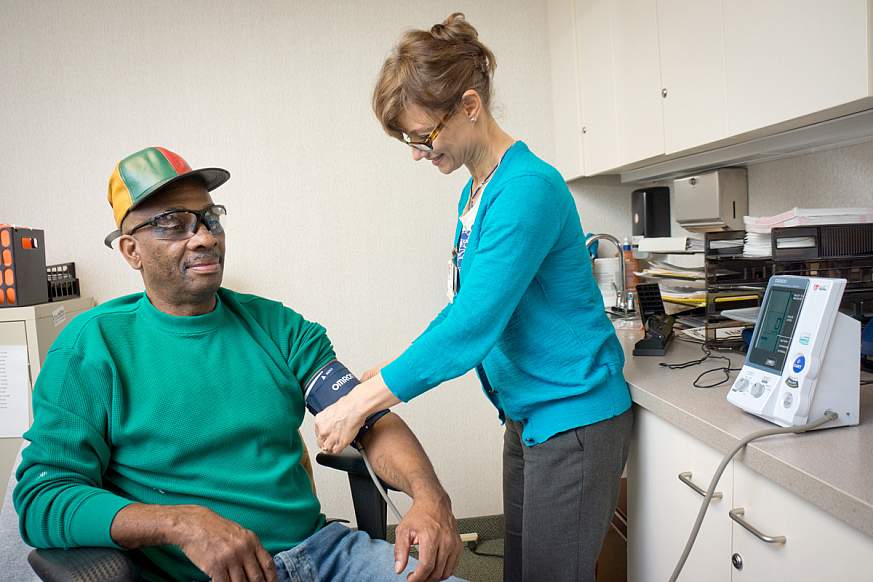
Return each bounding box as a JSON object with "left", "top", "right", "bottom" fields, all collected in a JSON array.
[{"left": 315, "top": 447, "right": 399, "bottom": 540}]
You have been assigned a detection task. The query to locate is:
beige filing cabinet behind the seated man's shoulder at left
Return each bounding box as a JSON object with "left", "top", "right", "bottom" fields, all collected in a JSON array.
[{"left": 0, "top": 298, "right": 94, "bottom": 499}]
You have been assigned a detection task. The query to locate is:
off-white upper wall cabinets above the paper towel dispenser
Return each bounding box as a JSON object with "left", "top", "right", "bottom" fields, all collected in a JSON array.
[{"left": 549, "top": 0, "right": 873, "bottom": 177}]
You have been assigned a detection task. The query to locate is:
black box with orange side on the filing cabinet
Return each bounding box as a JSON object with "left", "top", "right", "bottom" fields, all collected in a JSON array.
[{"left": 0, "top": 224, "right": 49, "bottom": 308}]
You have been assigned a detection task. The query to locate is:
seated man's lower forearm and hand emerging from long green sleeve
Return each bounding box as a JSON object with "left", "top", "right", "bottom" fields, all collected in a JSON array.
[{"left": 110, "top": 503, "right": 276, "bottom": 582}]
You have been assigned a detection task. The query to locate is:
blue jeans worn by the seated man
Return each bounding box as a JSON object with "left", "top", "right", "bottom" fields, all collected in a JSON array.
[{"left": 273, "top": 523, "right": 463, "bottom": 582}]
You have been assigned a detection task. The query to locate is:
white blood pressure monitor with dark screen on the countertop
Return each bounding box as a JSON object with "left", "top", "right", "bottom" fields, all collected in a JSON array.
[{"left": 727, "top": 275, "right": 861, "bottom": 428}]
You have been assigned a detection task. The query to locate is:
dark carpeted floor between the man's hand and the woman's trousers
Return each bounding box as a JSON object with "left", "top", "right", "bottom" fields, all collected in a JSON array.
[{"left": 388, "top": 515, "right": 503, "bottom": 582}]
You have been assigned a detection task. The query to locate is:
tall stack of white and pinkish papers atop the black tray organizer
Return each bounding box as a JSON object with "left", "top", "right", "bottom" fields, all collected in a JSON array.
[{"left": 743, "top": 208, "right": 873, "bottom": 257}]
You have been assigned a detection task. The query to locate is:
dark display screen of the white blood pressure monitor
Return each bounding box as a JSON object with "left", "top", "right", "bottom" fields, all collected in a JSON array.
[{"left": 749, "top": 287, "right": 805, "bottom": 375}]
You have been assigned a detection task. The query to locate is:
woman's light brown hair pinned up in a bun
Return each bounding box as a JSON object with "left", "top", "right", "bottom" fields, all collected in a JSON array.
[{"left": 373, "top": 12, "right": 496, "bottom": 139}]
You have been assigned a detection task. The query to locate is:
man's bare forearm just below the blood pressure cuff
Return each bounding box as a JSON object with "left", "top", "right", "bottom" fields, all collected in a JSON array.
[{"left": 362, "top": 414, "right": 451, "bottom": 504}]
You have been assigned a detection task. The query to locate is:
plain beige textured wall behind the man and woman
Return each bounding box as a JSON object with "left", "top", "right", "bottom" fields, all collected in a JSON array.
[{"left": 0, "top": 0, "right": 553, "bottom": 516}]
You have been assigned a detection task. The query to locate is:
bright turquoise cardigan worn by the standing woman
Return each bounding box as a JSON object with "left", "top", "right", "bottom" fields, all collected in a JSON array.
[{"left": 382, "top": 142, "right": 631, "bottom": 445}]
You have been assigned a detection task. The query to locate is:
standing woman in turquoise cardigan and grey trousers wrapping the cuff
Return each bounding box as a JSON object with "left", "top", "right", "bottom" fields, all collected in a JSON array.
[{"left": 316, "top": 14, "right": 633, "bottom": 582}]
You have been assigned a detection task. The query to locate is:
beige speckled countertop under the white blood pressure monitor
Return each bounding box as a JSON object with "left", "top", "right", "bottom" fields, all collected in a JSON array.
[{"left": 616, "top": 329, "right": 873, "bottom": 536}]
